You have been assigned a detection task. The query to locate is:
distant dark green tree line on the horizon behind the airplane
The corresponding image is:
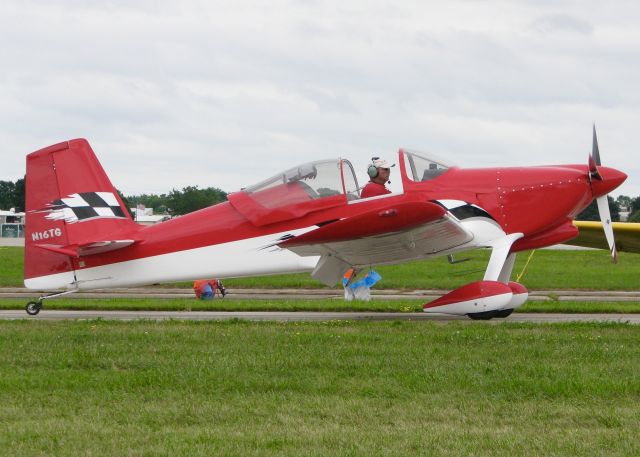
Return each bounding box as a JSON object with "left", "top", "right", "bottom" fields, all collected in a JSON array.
[{"left": 0, "top": 178, "right": 640, "bottom": 222}]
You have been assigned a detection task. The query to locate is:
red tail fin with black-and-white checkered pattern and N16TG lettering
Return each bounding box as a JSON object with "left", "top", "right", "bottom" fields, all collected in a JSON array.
[{"left": 24, "top": 139, "right": 139, "bottom": 289}]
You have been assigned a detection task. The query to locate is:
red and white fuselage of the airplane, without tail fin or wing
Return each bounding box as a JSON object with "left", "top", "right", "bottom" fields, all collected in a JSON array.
[{"left": 26, "top": 165, "right": 620, "bottom": 289}]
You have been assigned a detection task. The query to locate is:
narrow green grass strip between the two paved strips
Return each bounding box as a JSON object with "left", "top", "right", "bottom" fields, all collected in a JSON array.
[{"left": 0, "top": 298, "right": 640, "bottom": 313}]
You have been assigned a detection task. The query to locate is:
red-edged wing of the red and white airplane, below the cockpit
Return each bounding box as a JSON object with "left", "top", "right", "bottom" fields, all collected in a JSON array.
[{"left": 278, "top": 202, "right": 473, "bottom": 285}]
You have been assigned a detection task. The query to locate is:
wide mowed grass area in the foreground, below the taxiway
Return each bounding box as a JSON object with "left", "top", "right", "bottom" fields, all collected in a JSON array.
[{"left": 0, "top": 321, "right": 640, "bottom": 457}]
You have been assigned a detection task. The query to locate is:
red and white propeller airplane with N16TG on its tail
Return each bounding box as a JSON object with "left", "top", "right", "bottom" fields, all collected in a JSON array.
[{"left": 24, "top": 128, "right": 626, "bottom": 319}]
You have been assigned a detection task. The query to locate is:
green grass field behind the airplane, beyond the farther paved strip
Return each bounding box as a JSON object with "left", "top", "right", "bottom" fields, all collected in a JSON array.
[{"left": 0, "top": 247, "right": 640, "bottom": 290}]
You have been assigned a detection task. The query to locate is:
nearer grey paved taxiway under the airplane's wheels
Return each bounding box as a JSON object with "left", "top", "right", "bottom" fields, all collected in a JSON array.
[{"left": 0, "top": 309, "right": 640, "bottom": 324}]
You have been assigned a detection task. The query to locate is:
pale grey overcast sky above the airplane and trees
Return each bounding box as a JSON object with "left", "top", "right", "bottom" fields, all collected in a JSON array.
[{"left": 0, "top": 0, "right": 640, "bottom": 200}]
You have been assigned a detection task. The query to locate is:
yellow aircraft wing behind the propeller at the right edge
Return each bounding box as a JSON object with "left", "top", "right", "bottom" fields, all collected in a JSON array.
[{"left": 565, "top": 221, "right": 640, "bottom": 252}]
